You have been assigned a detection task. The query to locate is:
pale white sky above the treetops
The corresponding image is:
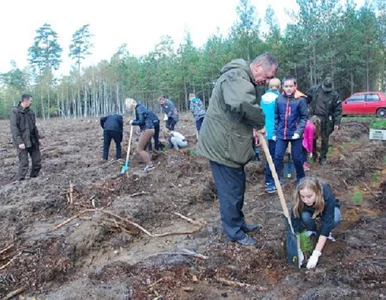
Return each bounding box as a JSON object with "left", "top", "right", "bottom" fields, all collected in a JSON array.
[{"left": 0, "top": 0, "right": 361, "bottom": 74}]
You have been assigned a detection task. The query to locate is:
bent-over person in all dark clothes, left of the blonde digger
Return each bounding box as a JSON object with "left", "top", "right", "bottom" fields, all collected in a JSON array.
[{"left": 100, "top": 114, "right": 123, "bottom": 160}]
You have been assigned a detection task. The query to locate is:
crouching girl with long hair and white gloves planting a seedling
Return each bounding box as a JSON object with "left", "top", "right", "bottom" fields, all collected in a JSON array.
[{"left": 291, "top": 177, "right": 342, "bottom": 269}]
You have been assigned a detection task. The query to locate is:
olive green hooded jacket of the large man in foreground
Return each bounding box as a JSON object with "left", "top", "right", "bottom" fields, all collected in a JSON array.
[{"left": 197, "top": 59, "right": 264, "bottom": 168}]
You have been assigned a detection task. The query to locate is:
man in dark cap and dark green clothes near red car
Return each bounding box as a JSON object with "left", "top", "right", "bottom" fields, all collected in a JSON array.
[{"left": 307, "top": 76, "right": 342, "bottom": 165}]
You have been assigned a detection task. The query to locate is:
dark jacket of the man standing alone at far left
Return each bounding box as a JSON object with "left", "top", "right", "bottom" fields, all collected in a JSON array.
[{"left": 10, "top": 104, "right": 41, "bottom": 148}]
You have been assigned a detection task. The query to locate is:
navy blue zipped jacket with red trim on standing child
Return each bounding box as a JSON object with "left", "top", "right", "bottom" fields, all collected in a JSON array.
[{"left": 273, "top": 91, "right": 308, "bottom": 140}]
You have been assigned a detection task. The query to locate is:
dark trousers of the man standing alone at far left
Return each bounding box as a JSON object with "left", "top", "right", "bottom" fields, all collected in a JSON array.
[{"left": 17, "top": 144, "right": 42, "bottom": 180}]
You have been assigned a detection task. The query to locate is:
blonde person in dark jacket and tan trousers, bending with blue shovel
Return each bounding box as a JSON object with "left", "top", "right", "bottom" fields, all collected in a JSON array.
[{"left": 125, "top": 98, "right": 159, "bottom": 172}]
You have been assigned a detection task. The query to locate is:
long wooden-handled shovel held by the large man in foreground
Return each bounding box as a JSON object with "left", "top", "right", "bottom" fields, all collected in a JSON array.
[{"left": 259, "top": 134, "right": 301, "bottom": 268}]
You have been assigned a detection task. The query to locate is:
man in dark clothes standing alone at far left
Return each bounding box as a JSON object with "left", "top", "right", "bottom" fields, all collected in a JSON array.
[{"left": 10, "top": 94, "right": 41, "bottom": 180}]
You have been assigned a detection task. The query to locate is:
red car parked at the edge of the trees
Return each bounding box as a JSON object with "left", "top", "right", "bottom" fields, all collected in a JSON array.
[{"left": 342, "top": 92, "right": 386, "bottom": 118}]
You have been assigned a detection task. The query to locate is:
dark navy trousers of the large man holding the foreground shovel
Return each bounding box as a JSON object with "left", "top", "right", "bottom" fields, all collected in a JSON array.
[{"left": 210, "top": 161, "right": 245, "bottom": 241}]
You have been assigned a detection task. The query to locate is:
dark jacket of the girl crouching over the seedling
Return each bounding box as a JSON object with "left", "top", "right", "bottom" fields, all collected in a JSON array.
[{"left": 291, "top": 184, "right": 340, "bottom": 237}]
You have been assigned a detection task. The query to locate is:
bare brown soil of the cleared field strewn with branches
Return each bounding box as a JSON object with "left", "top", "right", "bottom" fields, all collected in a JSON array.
[{"left": 0, "top": 115, "right": 386, "bottom": 300}]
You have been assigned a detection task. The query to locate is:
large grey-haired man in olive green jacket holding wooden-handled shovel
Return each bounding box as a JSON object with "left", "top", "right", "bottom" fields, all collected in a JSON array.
[{"left": 197, "top": 53, "right": 279, "bottom": 246}]
